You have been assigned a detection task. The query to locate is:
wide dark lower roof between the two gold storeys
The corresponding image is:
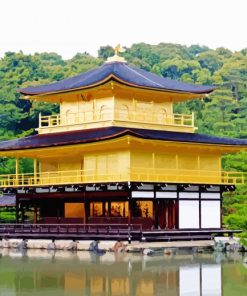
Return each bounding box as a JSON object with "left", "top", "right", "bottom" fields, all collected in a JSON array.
[{"left": 0, "top": 127, "right": 247, "bottom": 151}]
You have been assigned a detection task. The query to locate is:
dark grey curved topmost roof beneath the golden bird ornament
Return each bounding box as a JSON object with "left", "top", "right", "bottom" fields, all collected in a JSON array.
[{"left": 19, "top": 62, "right": 214, "bottom": 95}]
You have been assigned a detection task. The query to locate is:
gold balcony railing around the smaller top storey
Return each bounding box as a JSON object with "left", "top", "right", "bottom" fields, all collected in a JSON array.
[{"left": 39, "top": 110, "right": 194, "bottom": 128}]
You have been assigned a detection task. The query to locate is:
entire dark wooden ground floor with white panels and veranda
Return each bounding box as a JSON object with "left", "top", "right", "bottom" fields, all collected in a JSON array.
[{"left": 0, "top": 183, "right": 235, "bottom": 240}]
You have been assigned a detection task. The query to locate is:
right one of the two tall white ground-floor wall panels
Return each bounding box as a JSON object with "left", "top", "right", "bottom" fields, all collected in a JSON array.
[{"left": 201, "top": 200, "right": 221, "bottom": 228}]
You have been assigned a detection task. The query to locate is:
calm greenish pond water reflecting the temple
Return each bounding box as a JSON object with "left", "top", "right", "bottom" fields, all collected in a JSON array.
[{"left": 0, "top": 249, "right": 247, "bottom": 296}]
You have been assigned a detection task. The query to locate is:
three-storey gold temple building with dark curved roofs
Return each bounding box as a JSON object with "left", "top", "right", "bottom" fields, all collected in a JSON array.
[{"left": 0, "top": 49, "right": 247, "bottom": 231}]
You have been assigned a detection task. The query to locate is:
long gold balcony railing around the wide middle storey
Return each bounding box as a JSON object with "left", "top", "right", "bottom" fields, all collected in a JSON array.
[{"left": 0, "top": 168, "right": 244, "bottom": 188}]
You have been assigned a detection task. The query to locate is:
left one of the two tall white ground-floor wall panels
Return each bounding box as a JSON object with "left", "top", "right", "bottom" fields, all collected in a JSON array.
[{"left": 179, "top": 200, "right": 199, "bottom": 229}]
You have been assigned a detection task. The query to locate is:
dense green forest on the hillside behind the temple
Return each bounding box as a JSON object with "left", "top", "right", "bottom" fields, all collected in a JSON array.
[{"left": 0, "top": 43, "right": 247, "bottom": 235}]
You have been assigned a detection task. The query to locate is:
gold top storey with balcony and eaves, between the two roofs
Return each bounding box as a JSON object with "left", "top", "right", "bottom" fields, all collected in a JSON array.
[{"left": 26, "top": 80, "right": 204, "bottom": 134}]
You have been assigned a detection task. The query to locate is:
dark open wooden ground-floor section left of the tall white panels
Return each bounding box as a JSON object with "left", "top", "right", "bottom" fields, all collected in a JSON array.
[{"left": 16, "top": 192, "right": 178, "bottom": 230}]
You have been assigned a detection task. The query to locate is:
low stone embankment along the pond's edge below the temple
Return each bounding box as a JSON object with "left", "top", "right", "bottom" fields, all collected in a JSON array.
[{"left": 0, "top": 237, "right": 247, "bottom": 254}]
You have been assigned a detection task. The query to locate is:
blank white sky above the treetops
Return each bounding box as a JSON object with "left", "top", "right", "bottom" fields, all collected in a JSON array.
[{"left": 0, "top": 0, "right": 247, "bottom": 58}]
